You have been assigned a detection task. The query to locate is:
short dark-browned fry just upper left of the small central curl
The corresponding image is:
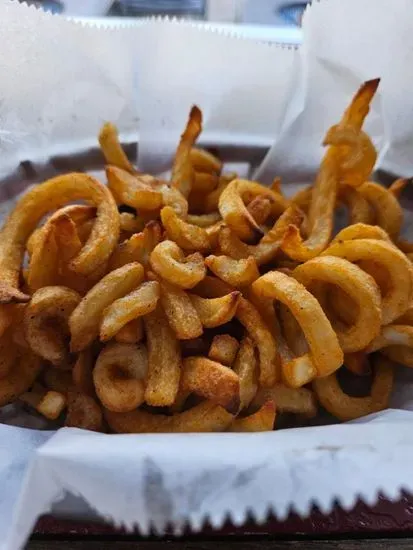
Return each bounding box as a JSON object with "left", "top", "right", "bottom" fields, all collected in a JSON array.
[{"left": 109, "top": 221, "right": 162, "bottom": 271}]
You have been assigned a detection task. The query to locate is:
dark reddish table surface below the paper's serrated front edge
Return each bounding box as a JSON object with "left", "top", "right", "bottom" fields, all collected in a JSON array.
[{"left": 27, "top": 494, "right": 413, "bottom": 550}]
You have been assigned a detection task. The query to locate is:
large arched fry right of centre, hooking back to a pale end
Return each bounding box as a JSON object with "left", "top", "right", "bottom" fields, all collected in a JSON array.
[{"left": 252, "top": 271, "right": 343, "bottom": 387}]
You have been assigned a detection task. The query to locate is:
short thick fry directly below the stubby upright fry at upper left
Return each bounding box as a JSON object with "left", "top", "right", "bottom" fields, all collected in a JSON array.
[{"left": 106, "top": 166, "right": 163, "bottom": 210}]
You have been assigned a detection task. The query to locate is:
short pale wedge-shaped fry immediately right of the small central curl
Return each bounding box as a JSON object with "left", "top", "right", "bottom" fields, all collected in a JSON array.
[{"left": 205, "top": 256, "right": 260, "bottom": 288}]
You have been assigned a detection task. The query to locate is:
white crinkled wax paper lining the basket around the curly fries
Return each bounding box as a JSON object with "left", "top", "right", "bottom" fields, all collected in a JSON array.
[{"left": 0, "top": 0, "right": 413, "bottom": 550}]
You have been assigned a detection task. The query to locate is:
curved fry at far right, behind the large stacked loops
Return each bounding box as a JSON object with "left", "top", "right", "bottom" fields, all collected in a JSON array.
[{"left": 357, "top": 181, "right": 403, "bottom": 239}]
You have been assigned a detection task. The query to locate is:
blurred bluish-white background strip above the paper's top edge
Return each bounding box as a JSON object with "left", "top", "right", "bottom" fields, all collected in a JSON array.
[{"left": 17, "top": 0, "right": 308, "bottom": 44}]
